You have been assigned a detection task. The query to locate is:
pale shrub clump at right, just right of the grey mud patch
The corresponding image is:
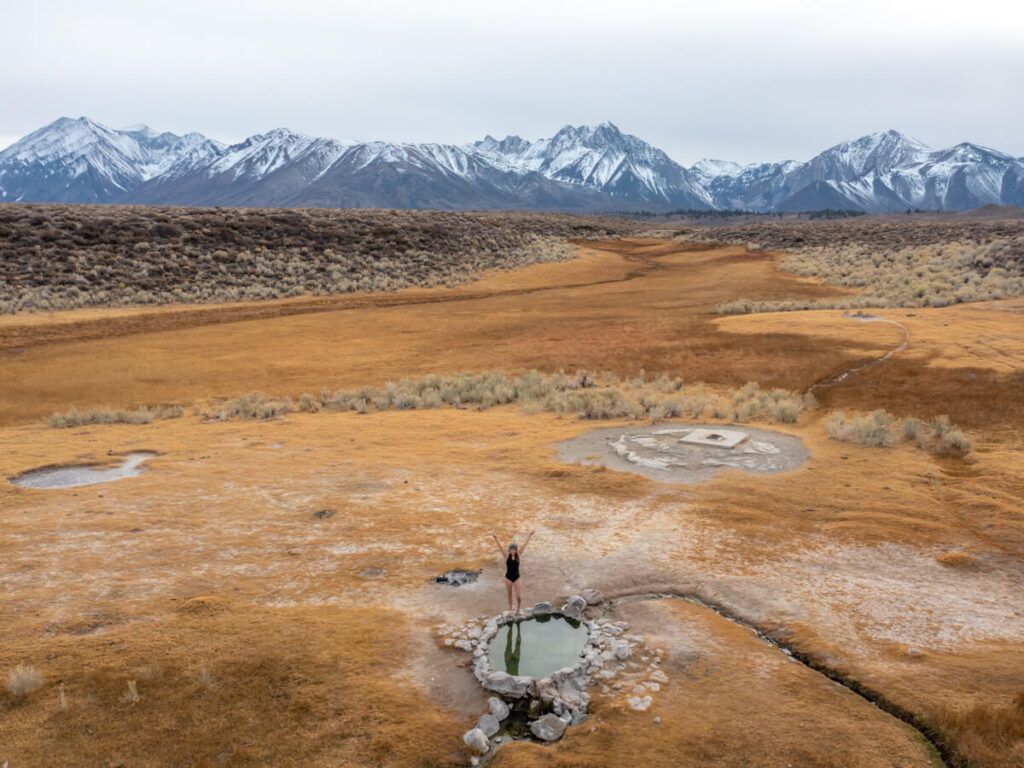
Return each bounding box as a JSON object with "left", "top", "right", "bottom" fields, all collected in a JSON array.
[{"left": 825, "top": 410, "right": 974, "bottom": 457}]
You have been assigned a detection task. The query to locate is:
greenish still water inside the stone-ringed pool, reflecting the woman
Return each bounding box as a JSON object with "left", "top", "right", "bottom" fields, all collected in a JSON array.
[{"left": 488, "top": 615, "right": 588, "bottom": 678}]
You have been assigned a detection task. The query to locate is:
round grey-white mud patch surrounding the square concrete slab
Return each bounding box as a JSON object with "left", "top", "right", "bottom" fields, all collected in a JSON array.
[{"left": 558, "top": 424, "right": 808, "bottom": 483}]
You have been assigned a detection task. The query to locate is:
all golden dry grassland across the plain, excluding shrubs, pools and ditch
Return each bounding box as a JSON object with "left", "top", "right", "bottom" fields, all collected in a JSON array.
[{"left": 0, "top": 241, "right": 1024, "bottom": 768}]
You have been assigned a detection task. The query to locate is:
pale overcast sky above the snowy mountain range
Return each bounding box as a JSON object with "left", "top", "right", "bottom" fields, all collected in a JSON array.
[{"left": 0, "top": 0, "right": 1024, "bottom": 164}]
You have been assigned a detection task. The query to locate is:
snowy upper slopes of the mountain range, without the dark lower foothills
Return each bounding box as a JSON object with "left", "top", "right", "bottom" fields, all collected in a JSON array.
[{"left": 0, "top": 117, "right": 1024, "bottom": 210}]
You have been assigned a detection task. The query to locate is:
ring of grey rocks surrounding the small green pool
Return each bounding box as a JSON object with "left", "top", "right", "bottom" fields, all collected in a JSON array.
[{"left": 455, "top": 590, "right": 630, "bottom": 760}]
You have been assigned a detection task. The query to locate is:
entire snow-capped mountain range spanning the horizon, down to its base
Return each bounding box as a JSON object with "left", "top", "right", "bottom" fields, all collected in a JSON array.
[{"left": 0, "top": 118, "right": 1024, "bottom": 212}]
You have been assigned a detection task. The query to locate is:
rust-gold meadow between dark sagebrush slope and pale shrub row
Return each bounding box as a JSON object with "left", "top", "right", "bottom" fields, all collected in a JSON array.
[{"left": 0, "top": 241, "right": 850, "bottom": 424}]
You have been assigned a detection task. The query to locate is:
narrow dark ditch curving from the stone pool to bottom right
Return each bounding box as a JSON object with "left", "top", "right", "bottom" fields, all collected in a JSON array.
[{"left": 602, "top": 593, "right": 950, "bottom": 768}]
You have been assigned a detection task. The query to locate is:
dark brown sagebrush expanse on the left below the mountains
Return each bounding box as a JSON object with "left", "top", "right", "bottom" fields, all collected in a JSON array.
[{"left": 0, "top": 204, "right": 636, "bottom": 313}]
